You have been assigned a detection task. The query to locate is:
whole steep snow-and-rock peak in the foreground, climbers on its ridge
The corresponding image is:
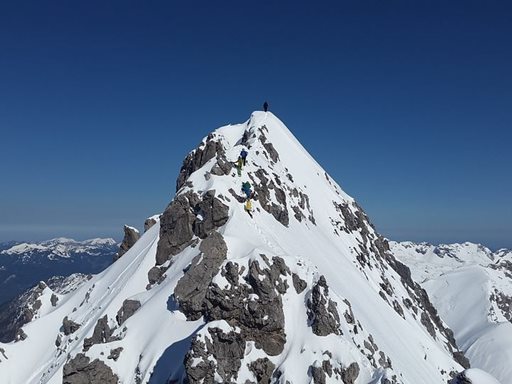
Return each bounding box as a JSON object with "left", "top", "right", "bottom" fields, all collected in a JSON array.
[{"left": 0, "top": 112, "right": 472, "bottom": 384}]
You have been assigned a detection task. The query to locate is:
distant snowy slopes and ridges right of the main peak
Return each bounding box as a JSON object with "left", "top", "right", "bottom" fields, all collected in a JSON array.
[{"left": 390, "top": 242, "right": 512, "bottom": 383}]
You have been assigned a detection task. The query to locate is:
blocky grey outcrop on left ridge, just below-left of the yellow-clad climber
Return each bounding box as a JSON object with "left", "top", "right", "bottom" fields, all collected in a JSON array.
[{"left": 156, "top": 190, "right": 229, "bottom": 265}]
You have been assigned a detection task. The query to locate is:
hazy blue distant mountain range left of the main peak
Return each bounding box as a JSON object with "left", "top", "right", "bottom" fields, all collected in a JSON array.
[{"left": 0, "top": 237, "right": 119, "bottom": 304}]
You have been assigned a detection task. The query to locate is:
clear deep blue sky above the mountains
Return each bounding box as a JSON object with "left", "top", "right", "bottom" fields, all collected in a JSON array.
[{"left": 0, "top": 0, "right": 512, "bottom": 248}]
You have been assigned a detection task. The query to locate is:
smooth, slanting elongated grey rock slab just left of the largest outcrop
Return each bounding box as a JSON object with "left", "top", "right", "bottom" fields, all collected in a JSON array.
[{"left": 174, "top": 232, "right": 228, "bottom": 320}]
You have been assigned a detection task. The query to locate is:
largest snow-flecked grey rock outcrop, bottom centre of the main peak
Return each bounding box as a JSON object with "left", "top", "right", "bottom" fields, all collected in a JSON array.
[{"left": 182, "top": 255, "right": 291, "bottom": 383}]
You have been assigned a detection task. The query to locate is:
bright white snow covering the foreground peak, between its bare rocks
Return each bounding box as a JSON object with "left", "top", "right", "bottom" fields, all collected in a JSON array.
[{"left": 0, "top": 112, "right": 480, "bottom": 384}]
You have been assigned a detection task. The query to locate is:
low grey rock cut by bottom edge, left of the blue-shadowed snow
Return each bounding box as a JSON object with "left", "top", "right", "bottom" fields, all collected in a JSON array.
[{"left": 63, "top": 353, "right": 119, "bottom": 384}]
